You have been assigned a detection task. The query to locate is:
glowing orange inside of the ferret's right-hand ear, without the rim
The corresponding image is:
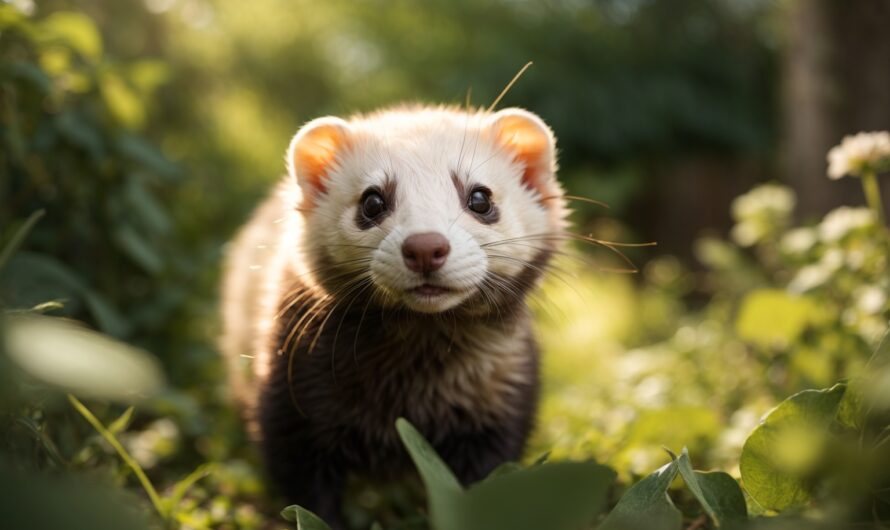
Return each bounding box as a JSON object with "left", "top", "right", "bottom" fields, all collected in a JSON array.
[{"left": 497, "top": 116, "right": 550, "bottom": 189}]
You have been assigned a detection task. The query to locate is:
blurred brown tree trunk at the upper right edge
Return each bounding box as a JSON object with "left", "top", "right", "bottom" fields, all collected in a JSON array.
[{"left": 783, "top": 0, "right": 890, "bottom": 217}]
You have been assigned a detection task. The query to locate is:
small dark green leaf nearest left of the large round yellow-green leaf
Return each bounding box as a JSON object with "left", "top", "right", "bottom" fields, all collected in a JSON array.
[{"left": 677, "top": 447, "right": 748, "bottom": 527}]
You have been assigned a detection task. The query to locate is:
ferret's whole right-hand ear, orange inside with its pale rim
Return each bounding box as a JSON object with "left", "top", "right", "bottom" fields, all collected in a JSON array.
[{"left": 490, "top": 108, "right": 556, "bottom": 195}]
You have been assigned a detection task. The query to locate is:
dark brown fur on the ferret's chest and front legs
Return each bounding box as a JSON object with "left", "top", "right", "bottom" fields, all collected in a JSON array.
[{"left": 256, "top": 253, "right": 549, "bottom": 524}]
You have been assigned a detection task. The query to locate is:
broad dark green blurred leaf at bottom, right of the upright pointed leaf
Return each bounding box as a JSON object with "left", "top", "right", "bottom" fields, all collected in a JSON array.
[{"left": 462, "top": 462, "right": 615, "bottom": 530}]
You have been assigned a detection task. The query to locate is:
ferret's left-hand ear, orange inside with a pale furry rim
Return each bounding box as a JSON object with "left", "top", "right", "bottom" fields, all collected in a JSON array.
[{"left": 287, "top": 116, "right": 349, "bottom": 205}]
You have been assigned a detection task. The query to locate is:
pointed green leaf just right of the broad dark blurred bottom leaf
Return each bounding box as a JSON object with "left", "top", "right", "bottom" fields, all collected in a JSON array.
[{"left": 597, "top": 460, "right": 682, "bottom": 530}]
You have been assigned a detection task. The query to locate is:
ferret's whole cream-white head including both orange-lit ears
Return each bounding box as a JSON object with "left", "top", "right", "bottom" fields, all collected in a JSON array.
[{"left": 287, "top": 108, "right": 565, "bottom": 313}]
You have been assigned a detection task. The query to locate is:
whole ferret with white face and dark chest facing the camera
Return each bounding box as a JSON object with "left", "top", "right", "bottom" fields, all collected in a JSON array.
[{"left": 221, "top": 106, "right": 567, "bottom": 526}]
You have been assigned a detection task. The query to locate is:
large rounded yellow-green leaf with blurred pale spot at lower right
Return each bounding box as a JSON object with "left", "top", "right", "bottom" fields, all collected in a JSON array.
[{"left": 739, "top": 384, "right": 846, "bottom": 511}]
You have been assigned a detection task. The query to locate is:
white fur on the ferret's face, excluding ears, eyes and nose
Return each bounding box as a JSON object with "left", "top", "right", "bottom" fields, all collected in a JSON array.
[{"left": 304, "top": 109, "right": 561, "bottom": 313}]
